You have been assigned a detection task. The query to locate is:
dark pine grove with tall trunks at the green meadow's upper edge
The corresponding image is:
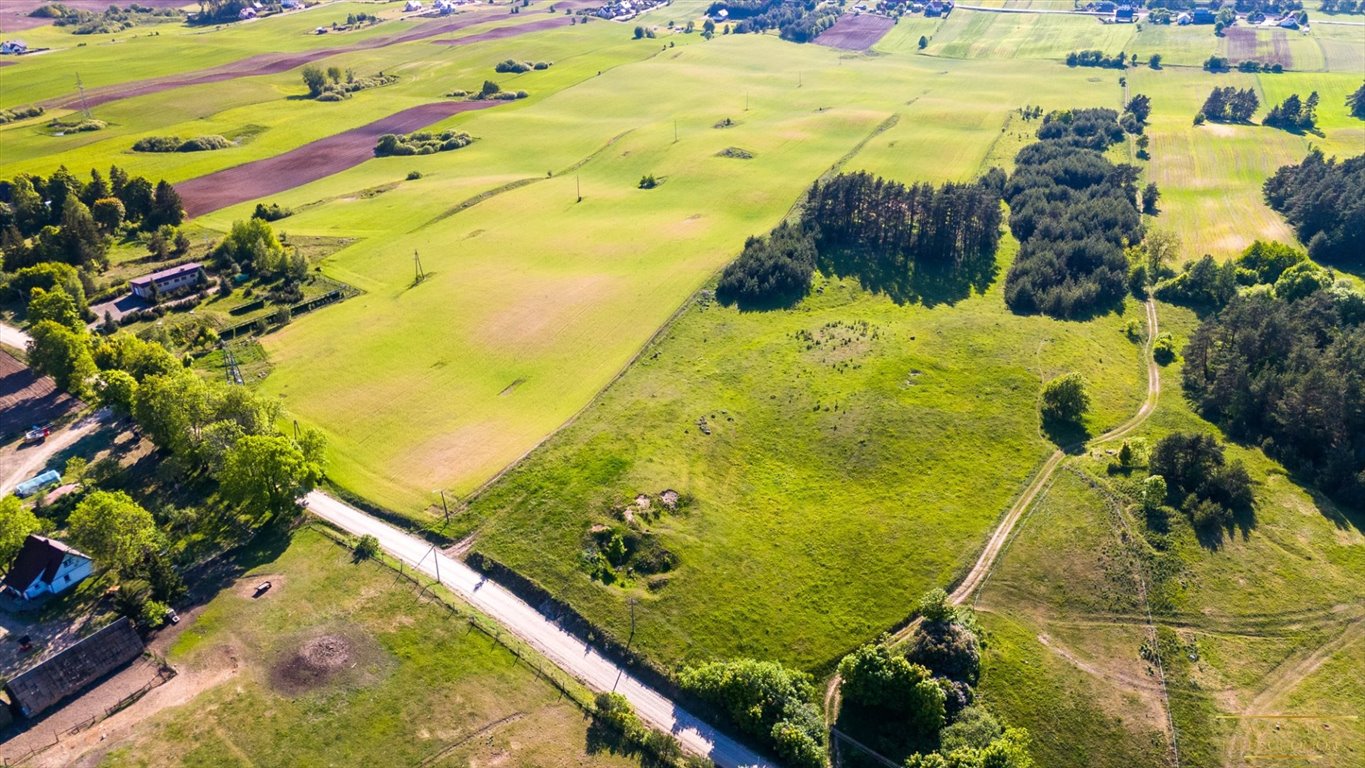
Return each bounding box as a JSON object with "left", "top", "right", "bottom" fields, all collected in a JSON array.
[{"left": 717, "top": 169, "right": 1005, "bottom": 307}]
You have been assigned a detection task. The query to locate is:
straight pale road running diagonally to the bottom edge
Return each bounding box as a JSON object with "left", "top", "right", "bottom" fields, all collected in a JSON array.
[{"left": 308, "top": 491, "right": 777, "bottom": 768}]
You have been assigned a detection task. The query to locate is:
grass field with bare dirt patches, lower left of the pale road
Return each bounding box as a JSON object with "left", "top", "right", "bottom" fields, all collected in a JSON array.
[{"left": 98, "top": 531, "right": 639, "bottom": 768}]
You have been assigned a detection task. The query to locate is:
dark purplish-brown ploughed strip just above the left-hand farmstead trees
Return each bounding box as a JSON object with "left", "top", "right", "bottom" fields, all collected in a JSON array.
[{"left": 176, "top": 101, "right": 501, "bottom": 217}]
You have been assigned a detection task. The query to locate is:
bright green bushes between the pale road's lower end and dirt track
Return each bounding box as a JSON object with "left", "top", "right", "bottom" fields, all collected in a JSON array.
[{"left": 678, "top": 659, "right": 824, "bottom": 768}]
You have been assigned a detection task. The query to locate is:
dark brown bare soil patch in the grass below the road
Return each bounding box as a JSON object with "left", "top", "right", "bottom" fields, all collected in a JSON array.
[{"left": 270, "top": 629, "right": 382, "bottom": 696}]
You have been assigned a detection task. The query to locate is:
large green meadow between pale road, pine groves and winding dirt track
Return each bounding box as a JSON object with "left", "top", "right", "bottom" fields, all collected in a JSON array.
[{"left": 465, "top": 244, "right": 1144, "bottom": 670}]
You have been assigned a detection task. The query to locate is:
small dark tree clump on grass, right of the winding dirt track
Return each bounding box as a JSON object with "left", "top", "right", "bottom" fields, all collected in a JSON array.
[{"left": 1148, "top": 432, "right": 1252, "bottom": 528}]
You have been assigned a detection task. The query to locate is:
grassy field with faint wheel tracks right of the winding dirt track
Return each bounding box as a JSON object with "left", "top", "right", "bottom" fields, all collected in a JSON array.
[{"left": 977, "top": 306, "right": 1365, "bottom": 767}]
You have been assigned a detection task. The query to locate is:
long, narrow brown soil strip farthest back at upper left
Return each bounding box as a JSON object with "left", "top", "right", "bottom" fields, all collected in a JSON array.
[{"left": 46, "top": 14, "right": 569, "bottom": 109}]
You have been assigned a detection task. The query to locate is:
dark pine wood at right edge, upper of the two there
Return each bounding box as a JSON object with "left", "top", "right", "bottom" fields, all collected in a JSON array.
[{"left": 1264, "top": 149, "right": 1365, "bottom": 267}]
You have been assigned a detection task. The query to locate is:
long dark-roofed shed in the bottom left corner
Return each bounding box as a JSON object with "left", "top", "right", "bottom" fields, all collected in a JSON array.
[{"left": 5, "top": 617, "right": 142, "bottom": 718}]
